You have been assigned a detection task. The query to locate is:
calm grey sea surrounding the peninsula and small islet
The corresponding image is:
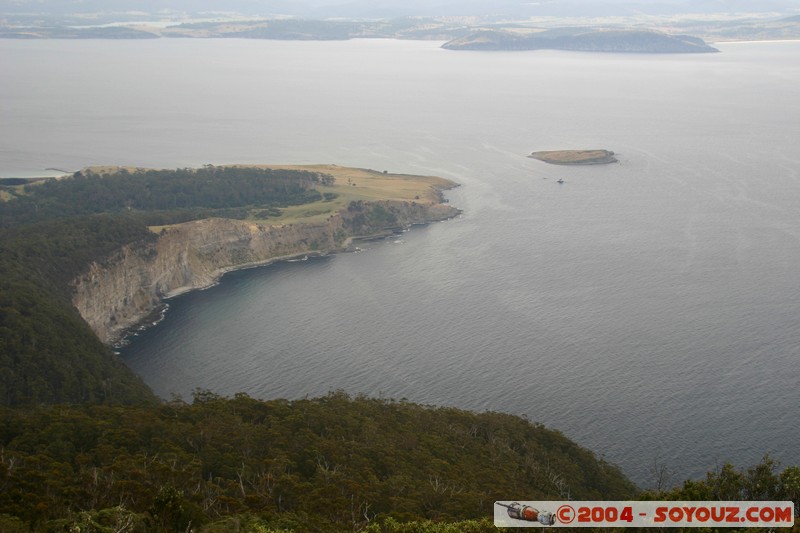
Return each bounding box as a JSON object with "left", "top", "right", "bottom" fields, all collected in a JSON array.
[{"left": 0, "top": 39, "right": 800, "bottom": 486}]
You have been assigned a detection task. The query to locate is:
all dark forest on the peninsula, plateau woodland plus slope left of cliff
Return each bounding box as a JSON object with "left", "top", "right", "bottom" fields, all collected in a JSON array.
[{"left": 0, "top": 166, "right": 333, "bottom": 405}]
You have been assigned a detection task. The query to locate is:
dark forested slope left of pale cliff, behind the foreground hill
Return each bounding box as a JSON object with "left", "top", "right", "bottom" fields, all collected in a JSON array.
[{"left": 0, "top": 215, "right": 155, "bottom": 405}]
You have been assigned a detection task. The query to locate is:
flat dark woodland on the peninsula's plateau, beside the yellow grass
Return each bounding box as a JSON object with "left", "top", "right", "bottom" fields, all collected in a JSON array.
[{"left": 0, "top": 165, "right": 333, "bottom": 227}]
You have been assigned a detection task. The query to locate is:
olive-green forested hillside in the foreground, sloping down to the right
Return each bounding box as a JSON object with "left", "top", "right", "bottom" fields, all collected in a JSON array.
[{"left": 0, "top": 391, "right": 635, "bottom": 531}]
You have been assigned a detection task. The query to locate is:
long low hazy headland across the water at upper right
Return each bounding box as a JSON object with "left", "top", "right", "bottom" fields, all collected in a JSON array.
[{"left": 443, "top": 28, "right": 719, "bottom": 54}]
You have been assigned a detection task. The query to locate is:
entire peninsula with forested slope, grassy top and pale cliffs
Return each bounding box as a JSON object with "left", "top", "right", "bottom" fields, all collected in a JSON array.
[{"left": 0, "top": 165, "right": 460, "bottom": 404}]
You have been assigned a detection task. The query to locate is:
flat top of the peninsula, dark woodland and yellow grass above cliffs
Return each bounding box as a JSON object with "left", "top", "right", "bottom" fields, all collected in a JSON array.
[{"left": 0, "top": 165, "right": 457, "bottom": 228}]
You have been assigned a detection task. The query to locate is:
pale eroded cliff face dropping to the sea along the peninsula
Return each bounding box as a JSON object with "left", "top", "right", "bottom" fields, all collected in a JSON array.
[{"left": 73, "top": 201, "right": 459, "bottom": 344}]
